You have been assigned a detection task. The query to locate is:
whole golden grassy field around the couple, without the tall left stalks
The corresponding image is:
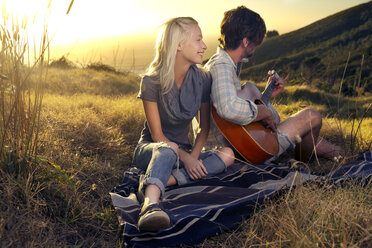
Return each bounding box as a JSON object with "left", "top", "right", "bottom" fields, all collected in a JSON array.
[{"left": 0, "top": 63, "right": 372, "bottom": 247}]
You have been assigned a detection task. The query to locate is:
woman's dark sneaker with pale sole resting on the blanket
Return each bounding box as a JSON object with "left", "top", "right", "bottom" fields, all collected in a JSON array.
[{"left": 137, "top": 203, "right": 170, "bottom": 232}]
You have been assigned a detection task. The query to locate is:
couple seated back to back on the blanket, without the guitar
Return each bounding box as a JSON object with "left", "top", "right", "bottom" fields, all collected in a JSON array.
[{"left": 133, "top": 6, "right": 343, "bottom": 231}]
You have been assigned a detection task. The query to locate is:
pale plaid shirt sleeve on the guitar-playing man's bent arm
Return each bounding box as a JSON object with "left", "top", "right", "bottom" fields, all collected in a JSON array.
[{"left": 210, "top": 63, "right": 257, "bottom": 125}]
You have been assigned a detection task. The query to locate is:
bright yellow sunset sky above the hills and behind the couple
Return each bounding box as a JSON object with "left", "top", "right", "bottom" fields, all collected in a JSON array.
[{"left": 1, "top": 0, "right": 368, "bottom": 71}]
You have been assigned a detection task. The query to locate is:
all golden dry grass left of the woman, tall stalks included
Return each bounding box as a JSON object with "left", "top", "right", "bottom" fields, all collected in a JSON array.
[{"left": 0, "top": 6, "right": 143, "bottom": 247}]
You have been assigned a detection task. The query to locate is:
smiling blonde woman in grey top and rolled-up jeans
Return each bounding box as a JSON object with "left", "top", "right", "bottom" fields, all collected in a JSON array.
[{"left": 133, "top": 17, "right": 234, "bottom": 231}]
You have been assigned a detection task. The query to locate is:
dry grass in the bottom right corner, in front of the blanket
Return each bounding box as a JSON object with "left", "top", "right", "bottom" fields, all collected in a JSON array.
[{"left": 201, "top": 179, "right": 372, "bottom": 247}]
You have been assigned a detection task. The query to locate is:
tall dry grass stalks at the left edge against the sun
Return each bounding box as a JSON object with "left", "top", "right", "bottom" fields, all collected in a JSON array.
[{"left": 0, "top": 6, "right": 49, "bottom": 172}]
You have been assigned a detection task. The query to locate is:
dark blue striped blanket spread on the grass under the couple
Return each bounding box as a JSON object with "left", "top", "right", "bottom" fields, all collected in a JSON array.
[{"left": 110, "top": 151, "right": 372, "bottom": 247}]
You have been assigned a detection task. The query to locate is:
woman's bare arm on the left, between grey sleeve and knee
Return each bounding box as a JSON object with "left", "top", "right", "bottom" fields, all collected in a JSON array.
[{"left": 142, "top": 100, "right": 170, "bottom": 142}]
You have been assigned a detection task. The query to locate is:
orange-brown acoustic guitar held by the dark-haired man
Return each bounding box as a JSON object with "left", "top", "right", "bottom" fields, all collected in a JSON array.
[{"left": 211, "top": 70, "right": 279, "bottom": 164}]
